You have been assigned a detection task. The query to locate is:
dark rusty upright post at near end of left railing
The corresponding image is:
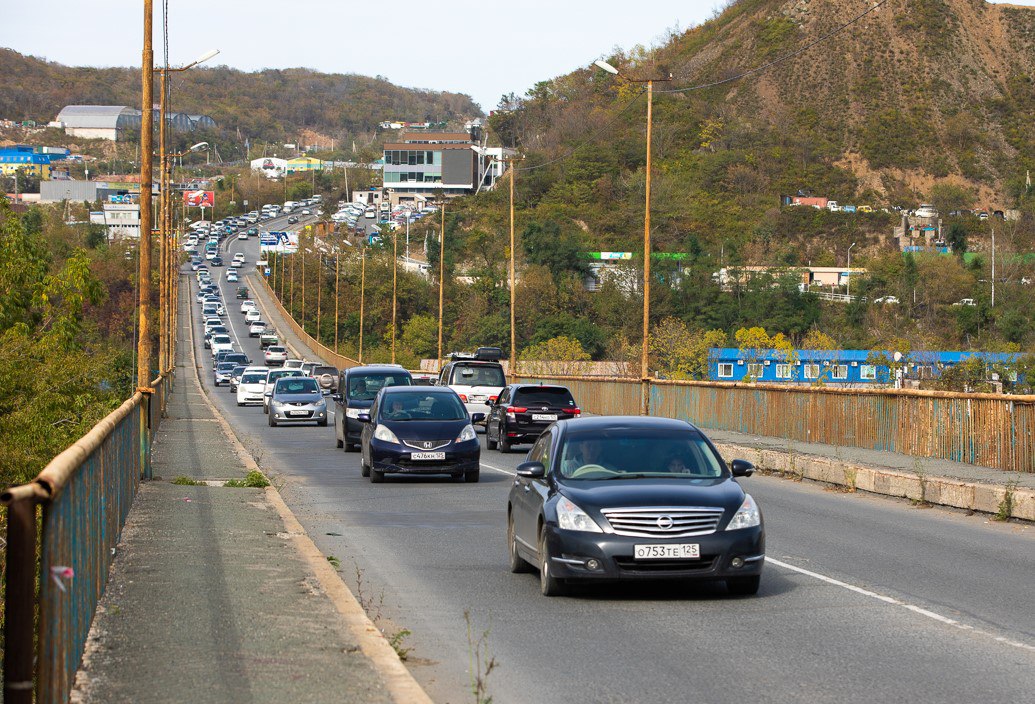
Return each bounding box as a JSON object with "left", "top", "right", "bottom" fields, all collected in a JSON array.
[{"left": 3, "top": 498, "right": 36, "bottom": 704}]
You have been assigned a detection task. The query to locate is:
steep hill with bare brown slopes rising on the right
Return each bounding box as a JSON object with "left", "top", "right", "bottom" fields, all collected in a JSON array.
[{"left": 491, "top": 0, "right": 1035, "bottom": 251}]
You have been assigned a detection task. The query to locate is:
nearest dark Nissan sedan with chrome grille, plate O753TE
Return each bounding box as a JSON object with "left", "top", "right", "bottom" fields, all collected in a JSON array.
[{"left": 507, "top": 416, "right": 765, "bottom": 596}]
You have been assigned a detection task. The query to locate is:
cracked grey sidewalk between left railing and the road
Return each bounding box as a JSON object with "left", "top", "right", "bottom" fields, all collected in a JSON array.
[{"left": 71, "top": 279, "right": 423, "bottom": 704}]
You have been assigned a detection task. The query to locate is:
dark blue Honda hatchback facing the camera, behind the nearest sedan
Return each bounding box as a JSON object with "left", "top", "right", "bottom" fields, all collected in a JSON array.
[{"left": 359, "top": 386, "right": 483, "bottom": 483}]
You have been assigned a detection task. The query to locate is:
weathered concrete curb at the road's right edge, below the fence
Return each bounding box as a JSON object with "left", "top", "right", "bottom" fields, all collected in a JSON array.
[{"left": 715, "top": 443, "right": 1035, "bottom": 521}]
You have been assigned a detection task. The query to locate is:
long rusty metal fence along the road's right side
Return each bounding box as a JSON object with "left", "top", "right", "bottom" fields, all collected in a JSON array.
[{"left": 520, "top": 376, "right": 1035, "bottom": 472}]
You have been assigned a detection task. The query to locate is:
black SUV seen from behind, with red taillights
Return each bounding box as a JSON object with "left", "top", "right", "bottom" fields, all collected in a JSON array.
[{"left": 485, "top": 384, "right": 582, "bottom": 452}]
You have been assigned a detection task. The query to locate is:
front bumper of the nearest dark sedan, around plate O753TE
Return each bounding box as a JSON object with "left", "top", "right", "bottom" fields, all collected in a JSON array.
[{"left": 546, "top": 525, "right": 766, "bottom": 580}]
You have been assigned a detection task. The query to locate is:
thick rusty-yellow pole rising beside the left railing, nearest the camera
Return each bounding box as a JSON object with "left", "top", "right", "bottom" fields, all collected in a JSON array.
[{"left": 137, "top": 0, "right": 154, "bottom": 479}]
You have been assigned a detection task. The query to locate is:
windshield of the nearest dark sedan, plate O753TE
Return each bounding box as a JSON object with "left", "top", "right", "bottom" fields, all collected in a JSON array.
[{"left": 558, "top": 428, "right": 722, "bottom": 480}]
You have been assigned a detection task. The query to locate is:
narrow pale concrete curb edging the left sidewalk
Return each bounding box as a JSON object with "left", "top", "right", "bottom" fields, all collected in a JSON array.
[{"left": 187, "top": 273, "right": 434, "bottom": 704}]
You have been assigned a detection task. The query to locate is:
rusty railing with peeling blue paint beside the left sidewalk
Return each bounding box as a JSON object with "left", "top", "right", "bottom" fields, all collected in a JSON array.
[{"left": 0, "top": 375, "right": 172, "bottom": 704}]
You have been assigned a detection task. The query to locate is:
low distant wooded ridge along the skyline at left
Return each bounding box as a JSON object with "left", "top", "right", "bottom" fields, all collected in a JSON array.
[{"left": 0, "top": 49, "right": 481, "bottom": 141}]
